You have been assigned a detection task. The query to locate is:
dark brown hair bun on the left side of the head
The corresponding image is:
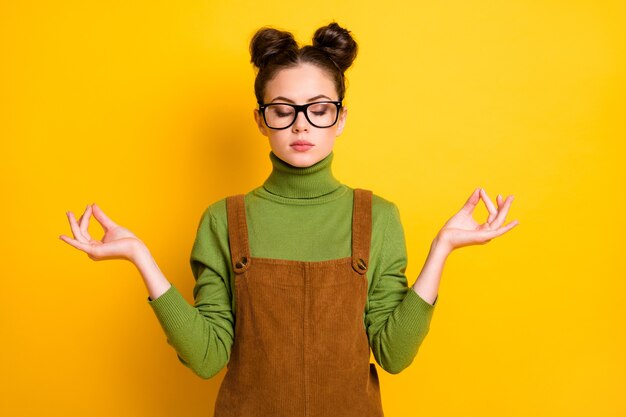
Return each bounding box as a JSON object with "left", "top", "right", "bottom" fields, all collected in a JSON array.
[{"left": 250, "top": 27, "right": 298, "bottom": 69}]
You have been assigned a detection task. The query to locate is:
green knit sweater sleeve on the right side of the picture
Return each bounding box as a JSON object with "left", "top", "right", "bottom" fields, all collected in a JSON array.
[{"left": 365, "top": 203, "right": 437, "bottom": 374}]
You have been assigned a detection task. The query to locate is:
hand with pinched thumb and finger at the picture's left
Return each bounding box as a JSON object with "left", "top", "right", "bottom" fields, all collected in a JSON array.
[{"left": 59, "top": 203, "right": 145, "bottom": 262}]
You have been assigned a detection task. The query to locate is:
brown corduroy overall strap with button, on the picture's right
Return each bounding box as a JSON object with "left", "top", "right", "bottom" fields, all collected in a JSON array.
[{"left": 352, "top": 188, "right": 372, "bottom": 275}]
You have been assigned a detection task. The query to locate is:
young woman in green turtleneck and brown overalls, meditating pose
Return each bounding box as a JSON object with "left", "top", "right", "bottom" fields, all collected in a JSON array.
[{"left": 61, "top": 23, "right": 517, "bottom": 417}]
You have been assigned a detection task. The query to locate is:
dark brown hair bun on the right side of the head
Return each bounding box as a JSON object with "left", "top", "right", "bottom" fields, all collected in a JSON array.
[{"left": 313, "top": 22, "right": 358, "bottom": 72}]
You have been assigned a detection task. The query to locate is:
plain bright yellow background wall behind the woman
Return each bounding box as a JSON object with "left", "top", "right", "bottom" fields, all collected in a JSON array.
[{"left": 0, "top": 0, "right": 626, "bottom": 417}]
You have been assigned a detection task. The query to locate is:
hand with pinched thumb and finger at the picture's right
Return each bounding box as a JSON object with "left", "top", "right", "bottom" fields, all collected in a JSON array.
[{"left": 436, "top": 188, "right": 519, "bottom": 252}]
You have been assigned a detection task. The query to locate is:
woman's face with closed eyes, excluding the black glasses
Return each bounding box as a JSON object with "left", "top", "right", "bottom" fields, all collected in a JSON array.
[{"left": 254, "top": 64, "right": 347, "bottom": 167}]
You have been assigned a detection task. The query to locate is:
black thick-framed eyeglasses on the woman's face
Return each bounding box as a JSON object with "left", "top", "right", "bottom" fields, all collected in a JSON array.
[{"left": 259, "top": 101, "right": 342, "bottom": 130}]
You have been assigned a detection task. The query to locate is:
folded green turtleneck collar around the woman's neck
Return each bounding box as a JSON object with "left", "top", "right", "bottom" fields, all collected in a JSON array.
[{"left": 263, "top": 151, "right": 341, "bottom": 198}]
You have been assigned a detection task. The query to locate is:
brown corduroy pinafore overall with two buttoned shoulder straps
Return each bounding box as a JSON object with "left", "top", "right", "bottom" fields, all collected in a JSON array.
[{"left": 215, "top": 189, "right": 383, "bottom": 417}]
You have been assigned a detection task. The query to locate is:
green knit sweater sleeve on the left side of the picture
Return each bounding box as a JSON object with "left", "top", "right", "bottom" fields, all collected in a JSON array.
[{"left": 148, "top": 203, "right": 234, "bottom": 379}]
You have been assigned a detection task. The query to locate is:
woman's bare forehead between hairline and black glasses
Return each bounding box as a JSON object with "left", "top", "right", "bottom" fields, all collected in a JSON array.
[{"left": 264, "top": 64, "right": 338, "bottom": 103}]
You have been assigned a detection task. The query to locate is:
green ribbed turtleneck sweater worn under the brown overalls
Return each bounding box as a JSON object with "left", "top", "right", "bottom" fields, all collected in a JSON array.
[{"left": 148, "top": 152, "right": 437, "bottom": 379}]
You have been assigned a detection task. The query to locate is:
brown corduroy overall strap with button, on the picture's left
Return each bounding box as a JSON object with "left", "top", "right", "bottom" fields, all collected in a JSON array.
[{"left": 226, "top": 194, "right": 250, "bottom": 274}]
